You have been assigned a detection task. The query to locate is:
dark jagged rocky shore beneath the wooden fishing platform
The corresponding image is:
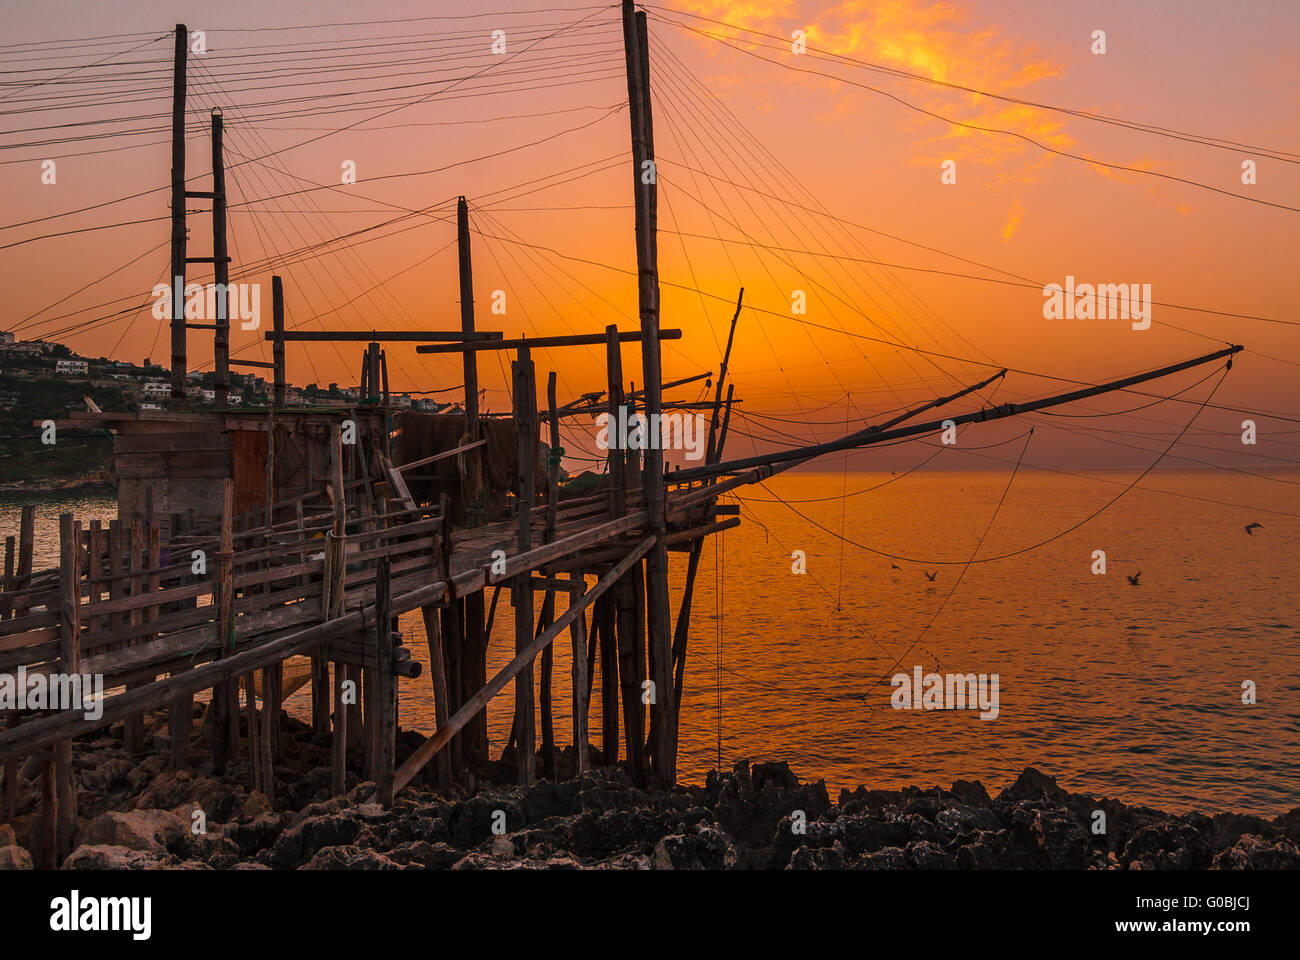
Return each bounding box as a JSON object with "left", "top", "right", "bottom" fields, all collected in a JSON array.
[{"left": 0, "top": 706, "right": 1300, "bottom": 870}]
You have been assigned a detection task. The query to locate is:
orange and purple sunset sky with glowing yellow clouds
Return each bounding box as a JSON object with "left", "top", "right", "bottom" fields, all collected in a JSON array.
[{"left": 0, "top": 0, "right": 1300, "bottom": 471}]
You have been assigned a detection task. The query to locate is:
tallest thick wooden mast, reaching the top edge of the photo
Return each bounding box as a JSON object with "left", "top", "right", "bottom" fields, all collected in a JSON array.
[{"left": 623, "top": 0, "right": 677, "bottom": 788}]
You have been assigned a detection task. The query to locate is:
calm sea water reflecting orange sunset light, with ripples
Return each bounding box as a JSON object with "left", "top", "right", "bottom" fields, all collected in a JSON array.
[{"left": 0, "top": 471, "right": 1300, "bottom": 816}]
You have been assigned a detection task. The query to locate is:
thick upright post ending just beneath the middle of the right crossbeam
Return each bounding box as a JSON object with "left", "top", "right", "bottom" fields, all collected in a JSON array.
[{"left": 511, "top": 347, "right": 537, "bottom": 787}]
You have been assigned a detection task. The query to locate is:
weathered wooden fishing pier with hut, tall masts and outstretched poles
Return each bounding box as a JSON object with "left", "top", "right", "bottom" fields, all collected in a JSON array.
[{"left": 0, "top": 1, "right": 1240, "bottom": 865}]
